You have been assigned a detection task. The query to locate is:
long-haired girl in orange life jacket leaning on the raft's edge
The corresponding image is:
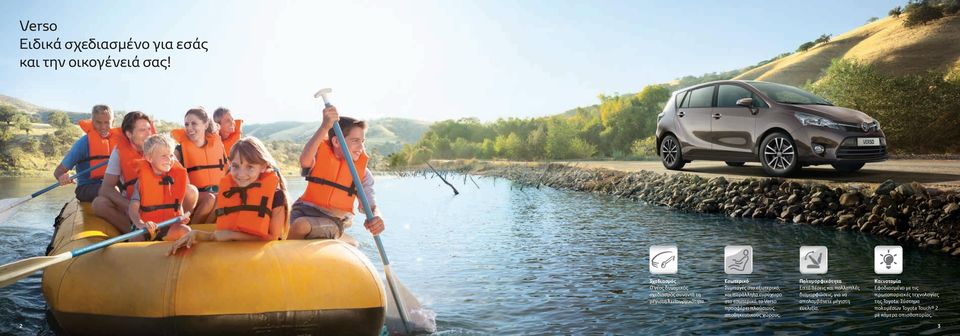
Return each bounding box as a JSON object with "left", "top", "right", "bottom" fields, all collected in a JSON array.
[{"left": 170, "top": 137, "right": 290, "bottom": 254}]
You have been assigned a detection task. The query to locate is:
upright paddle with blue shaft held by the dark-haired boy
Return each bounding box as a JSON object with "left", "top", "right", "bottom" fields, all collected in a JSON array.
[{"left": 313, "top": 88, "right": 436, "bottom": 334}]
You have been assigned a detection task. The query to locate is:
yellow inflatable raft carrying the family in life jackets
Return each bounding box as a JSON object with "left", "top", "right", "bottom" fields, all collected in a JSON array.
[{"left": 43, "top": 201, "right": 386, "bottom": 335}]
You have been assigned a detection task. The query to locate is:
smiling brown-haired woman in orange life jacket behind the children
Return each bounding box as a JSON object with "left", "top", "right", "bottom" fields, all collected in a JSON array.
[{"left": 170, "top": 107, "right": 227, "bottom": 224}]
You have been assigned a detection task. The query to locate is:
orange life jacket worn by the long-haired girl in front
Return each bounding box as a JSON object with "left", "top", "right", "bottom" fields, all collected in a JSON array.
[{"left": 214, "top": 172, "right": 280, "bottom": 239}]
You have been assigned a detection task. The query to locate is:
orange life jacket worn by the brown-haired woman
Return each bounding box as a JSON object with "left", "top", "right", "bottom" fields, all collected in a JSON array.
[{"left": 170, "top": 128, "right": 227, "bottom": 193}]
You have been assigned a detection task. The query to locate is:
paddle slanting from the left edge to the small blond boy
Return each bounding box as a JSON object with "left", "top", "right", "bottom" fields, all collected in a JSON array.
[{"left": 0, "top": 212, "right": 190, "bottom": 288}]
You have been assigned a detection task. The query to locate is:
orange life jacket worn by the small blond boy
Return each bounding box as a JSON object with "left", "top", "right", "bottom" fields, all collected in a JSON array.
[{"left": 137, "top": 160, "right": 187, "bottom": 223}]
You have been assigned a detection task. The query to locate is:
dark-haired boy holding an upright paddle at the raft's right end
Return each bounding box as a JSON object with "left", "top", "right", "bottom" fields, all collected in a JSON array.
[{"left": 289, "top": 106, "right": 384, "bottom": 244}]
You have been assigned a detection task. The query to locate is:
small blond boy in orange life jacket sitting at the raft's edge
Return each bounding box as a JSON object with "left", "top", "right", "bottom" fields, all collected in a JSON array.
[{"left": 128, "top": 134, "right": 190, "bottom": 241}]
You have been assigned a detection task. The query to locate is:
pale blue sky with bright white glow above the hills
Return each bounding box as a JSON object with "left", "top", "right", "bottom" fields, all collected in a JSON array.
[{"left": 0, "top": 0, "right": 905, "bottom": 123}]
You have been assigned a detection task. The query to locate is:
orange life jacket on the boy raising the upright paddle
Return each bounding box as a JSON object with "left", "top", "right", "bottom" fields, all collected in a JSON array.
[{"left": 300, "top": 140, "right": 367, "bottom": 213}]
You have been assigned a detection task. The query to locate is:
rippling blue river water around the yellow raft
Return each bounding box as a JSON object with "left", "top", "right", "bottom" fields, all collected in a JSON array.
[{"left": 0, "top": 176, "right": 960, "bottom": 335}]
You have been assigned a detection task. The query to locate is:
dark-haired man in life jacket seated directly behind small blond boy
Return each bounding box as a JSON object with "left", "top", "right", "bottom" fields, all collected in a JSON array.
[{"left": 92, "top": 111, "right": 197, "bottom": 233}]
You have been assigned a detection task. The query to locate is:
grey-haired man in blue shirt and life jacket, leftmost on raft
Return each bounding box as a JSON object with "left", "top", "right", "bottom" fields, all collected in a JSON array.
[{"left": 53, "top": 105, "right": 120, "bottom": 202}]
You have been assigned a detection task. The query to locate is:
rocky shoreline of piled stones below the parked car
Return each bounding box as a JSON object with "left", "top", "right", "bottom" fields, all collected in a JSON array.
[{"left": 441, "top": 161, "right": 960, "bottom": 256}]
